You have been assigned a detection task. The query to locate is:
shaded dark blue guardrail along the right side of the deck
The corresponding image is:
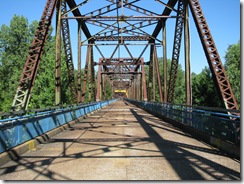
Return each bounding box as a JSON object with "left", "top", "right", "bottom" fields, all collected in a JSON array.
[{"left": 126, "top": 99, "right": 240, "bottom": 146}]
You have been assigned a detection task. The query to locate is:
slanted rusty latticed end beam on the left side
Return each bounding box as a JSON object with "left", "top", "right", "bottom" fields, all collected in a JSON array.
[{"left": 12, "top": 0, "right": 57, "bottom": 110}]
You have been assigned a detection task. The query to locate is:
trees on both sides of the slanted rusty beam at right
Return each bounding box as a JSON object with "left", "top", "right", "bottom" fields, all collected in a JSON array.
[{"left": 192, "top": 42, "right": 241, "bottom": 108}]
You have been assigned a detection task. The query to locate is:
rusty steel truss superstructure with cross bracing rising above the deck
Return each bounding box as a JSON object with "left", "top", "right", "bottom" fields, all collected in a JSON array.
[{"left": 13, "top": 0, "right": 238, "bottom": 115}]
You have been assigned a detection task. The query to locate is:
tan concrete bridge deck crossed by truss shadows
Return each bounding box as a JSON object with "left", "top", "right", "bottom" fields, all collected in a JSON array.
[{"left": 0, "top": 101, "right": 240, "bottom": 180}]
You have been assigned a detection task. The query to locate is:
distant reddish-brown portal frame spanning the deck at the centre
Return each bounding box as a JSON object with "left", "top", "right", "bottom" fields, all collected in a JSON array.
[{"left": 96, "top": 57, "right": 147, "bottom": 101}]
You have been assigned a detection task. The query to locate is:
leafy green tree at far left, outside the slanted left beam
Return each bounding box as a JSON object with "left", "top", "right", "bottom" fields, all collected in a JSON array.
[{"left": 0, "top": 15, "right": 31, "bottom": 111}]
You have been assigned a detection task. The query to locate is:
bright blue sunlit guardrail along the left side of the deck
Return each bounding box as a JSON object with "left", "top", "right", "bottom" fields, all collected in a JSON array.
[{"left": 0, "top": 99, "right": 117, "bottom": 153}]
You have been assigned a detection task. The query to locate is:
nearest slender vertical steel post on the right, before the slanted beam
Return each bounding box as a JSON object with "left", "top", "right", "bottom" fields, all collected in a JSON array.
[{"left": 184, "top": 1, "right": 192, "bottom": 105}]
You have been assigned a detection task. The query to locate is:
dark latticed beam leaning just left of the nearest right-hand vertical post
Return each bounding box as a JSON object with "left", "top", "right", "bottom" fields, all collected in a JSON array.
[{"left": 168, "top": 0, "right": 185, "bottom": 103}]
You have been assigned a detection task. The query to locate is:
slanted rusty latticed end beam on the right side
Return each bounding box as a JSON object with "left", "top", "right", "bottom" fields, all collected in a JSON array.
[{"left": 189, "top": 0, "right": 239, "bottom": 109}]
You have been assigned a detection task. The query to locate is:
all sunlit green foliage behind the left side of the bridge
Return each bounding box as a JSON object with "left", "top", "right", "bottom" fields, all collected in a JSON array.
[{"left": 0, "top": 15, "right": 71, "bottom": 111}]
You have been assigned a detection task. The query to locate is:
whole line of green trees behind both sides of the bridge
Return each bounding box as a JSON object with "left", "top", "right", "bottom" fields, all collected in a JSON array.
[{"left": 0, "top": 15, "right": 241, "bottom": 112}]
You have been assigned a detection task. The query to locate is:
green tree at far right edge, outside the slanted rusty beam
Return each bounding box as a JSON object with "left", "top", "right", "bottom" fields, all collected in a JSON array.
[{"left": 225, "top": 41, "right": 241, "bottom": 107}]
